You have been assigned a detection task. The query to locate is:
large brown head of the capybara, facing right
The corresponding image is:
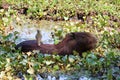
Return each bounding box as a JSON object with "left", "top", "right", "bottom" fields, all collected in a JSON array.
[{"left": 57, "top": 32, "right": 97, "bottom": 55}]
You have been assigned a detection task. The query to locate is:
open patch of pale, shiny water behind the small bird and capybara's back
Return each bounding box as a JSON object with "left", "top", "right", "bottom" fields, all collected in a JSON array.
[{"left": 12, "top": 20, "right": 61, "bottom": 44}]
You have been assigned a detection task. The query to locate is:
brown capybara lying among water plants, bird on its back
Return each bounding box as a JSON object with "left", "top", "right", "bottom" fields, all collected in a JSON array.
[{"left": 16, "top": 32, "right": 97, "bottom": 55}]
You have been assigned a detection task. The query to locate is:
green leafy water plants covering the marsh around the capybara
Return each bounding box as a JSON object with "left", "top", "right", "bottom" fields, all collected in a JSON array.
[{"left": 0, "top": 0, "right": 120, "bottom": 80}]
